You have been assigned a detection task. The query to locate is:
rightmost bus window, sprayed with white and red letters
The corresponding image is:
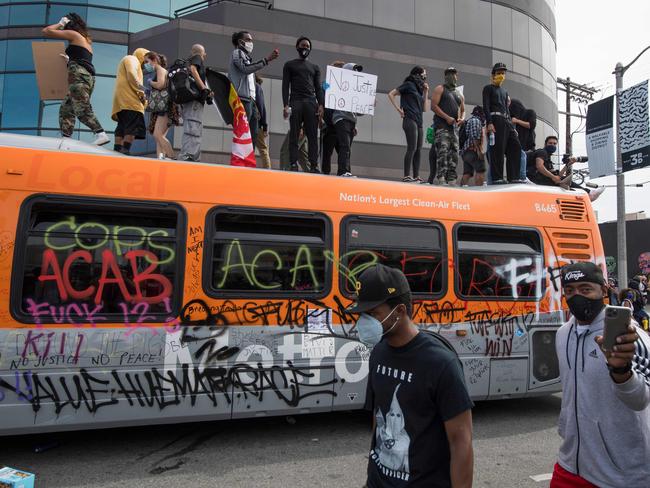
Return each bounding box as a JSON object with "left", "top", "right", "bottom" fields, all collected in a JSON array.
[{"left": 456, "top": 224, "right": 545, "bottom": 300}]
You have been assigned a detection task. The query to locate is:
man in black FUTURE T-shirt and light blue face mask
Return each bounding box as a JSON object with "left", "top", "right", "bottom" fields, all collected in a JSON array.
[{"left": 348, "top": 264, "right": 474, "bottom": 488}]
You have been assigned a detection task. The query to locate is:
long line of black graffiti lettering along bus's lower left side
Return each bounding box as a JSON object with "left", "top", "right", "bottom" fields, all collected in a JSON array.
[{"left": 0, "top": 361, "right": 338, "bottom": 415}]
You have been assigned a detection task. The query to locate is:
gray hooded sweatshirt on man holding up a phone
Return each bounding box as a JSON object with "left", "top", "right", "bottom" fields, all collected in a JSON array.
[{"left": 555, "top": 309, "right": 650, "bottom": 488}]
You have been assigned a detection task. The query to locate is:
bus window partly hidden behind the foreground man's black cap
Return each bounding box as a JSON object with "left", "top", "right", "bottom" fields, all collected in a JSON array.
[{"left": 339, "top": 217, "right": 446, "bottom": 298}]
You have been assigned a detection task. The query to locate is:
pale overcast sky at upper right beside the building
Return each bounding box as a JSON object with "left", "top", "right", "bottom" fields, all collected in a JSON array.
[{"left": 552, "top": 0, "right": 650, "bottom": 222}]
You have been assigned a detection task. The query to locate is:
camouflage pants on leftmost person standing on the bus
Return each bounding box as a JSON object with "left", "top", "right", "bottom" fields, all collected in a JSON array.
[{"left": 59, "top": 62, "right": 104, "bottom": 137}]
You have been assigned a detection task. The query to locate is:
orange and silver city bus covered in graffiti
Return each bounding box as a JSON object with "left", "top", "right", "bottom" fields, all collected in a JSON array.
[{"left": 0, "top": 134, "right": 604, "bottom": 435}]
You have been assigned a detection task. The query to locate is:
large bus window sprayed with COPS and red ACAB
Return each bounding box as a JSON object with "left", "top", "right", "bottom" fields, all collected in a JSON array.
[{"left": 12, "top": 197, "right": 184, "bottom": 323}]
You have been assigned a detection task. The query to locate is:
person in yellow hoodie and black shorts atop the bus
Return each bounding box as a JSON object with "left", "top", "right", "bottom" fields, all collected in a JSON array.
[{"left": 111, "top": 47, "right": 149, "bottom": 154}]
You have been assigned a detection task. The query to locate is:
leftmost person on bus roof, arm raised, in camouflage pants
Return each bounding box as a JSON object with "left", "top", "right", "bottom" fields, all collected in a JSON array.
[{"left": 43, "top": 12, "right": 110, "bottom": 146}]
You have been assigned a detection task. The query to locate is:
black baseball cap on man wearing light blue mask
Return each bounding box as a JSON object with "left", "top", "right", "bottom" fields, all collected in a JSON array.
[{"left": 346, "top": 264, "right": 411, "bottom": 313}]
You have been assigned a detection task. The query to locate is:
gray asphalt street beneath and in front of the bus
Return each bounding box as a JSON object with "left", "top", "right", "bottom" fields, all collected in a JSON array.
[{"left": 0, "top": 395, "right": 561, "bottom": 488}]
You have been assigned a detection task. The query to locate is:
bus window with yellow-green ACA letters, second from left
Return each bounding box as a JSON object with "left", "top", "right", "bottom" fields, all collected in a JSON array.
[{"left": 206, "top": 209, "right": 330, "bottom": 297}]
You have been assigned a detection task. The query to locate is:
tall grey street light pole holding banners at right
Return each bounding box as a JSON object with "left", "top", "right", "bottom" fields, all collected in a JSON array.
[{"left": 614, "top": 63, "right": 627, "bottom": 290}]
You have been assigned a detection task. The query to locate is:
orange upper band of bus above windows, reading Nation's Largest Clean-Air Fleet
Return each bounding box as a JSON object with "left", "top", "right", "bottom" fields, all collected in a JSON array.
[{"left": 0, "top": 134, "right": 595, "bottom": 226}]
